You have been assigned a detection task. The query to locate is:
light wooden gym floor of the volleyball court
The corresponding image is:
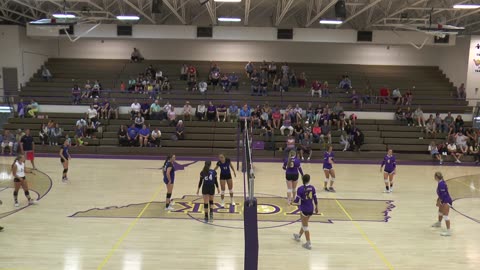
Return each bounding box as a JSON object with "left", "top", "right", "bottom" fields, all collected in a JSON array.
[{"left": 0, "top": 157, "right": 480, "bottom": 270}]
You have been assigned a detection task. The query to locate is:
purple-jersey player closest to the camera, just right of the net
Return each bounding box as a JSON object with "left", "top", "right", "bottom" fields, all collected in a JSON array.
[{"left": 293, "top": 174, "right": 318, "bottom": 249}]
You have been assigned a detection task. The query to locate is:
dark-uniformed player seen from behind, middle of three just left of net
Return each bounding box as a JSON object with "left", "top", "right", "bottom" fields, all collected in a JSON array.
[{"left": 197, "top": 160, "right": 220, "bottom": 222}]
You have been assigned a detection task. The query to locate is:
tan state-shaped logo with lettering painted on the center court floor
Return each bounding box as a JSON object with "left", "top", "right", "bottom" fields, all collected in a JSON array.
[{"left": 71, "top": 195, "right": 394, "bottom": 228}]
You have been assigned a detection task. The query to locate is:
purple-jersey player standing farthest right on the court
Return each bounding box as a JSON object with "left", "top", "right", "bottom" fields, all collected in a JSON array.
[{"left": 432, "top": 172, "right": 453, "bottom": 236}]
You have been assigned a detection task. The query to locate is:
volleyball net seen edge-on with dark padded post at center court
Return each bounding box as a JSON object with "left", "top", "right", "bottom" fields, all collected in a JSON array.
[{"left": 240, "top": 120, "right": 258, "bottom": 270}]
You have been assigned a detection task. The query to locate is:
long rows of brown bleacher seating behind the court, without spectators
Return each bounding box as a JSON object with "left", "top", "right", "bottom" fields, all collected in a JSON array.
[{"left": 4, "top": 59, "right": 471, "bottom": 160}]
